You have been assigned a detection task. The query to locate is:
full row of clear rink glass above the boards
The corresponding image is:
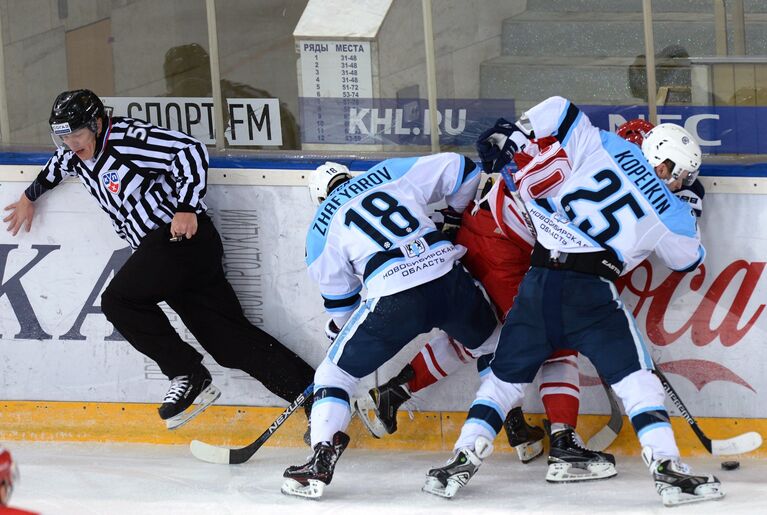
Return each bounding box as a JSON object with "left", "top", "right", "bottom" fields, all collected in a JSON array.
[{"left": 0, "top": 0, "right": 767, "bottom": 156}]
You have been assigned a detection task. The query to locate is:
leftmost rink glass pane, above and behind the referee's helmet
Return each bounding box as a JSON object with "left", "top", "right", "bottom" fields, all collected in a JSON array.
[{"left": 0, "top": 0, "right": 207, "bottom": 150}]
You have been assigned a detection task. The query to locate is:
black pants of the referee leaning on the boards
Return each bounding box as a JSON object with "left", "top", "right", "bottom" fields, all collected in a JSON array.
[{"left": 101, "top": 214, "right": 314, "bottom": 401}]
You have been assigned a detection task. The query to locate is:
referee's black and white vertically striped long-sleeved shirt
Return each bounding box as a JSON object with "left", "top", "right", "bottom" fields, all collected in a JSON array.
[{"left": 32, "top": 117, "right": 208, "bottom": 249}]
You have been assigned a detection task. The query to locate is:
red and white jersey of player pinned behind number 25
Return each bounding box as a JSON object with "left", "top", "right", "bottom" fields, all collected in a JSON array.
[{"left": 485, "top": 138, "right": 572, "bottom": 246}]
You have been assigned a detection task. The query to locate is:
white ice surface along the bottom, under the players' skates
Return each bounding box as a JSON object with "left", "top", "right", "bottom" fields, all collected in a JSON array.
[{"left": 5, "top": 442, "right": 767, "bottom": 515}]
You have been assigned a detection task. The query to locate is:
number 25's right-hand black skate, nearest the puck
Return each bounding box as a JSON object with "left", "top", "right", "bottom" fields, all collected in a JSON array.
[{"left": 642, "top": 447, "right": 724, "bottom": 506}]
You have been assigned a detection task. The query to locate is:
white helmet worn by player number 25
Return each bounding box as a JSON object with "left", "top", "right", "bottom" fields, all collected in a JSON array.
[{"left": 642, "top": 123, "right": 702, "bottom": 186}]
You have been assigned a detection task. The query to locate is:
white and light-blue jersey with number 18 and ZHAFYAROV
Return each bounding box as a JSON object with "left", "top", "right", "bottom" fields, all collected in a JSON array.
[{"left": 306, "top": 153, "right": 480, "bottom": 318}]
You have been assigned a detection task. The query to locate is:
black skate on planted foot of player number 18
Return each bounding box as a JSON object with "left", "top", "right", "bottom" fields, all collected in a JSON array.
[{"left": 282, "top": 431, "right": 350, "bottom": 499}]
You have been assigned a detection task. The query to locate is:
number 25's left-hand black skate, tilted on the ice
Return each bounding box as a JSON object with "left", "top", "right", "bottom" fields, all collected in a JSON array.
[{"left": 422, "top": 436, "right": 493, "bottom": 499}]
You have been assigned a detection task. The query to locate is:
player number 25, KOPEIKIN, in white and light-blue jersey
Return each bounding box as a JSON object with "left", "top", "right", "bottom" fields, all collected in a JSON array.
[{"left": 424, "top": 97, "right": 724, "bottom": 506}]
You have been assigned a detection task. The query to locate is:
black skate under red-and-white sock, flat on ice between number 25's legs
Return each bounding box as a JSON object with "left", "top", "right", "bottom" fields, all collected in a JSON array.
[{"left": 546, "top": 426, "right": 617, "bottom": 483}]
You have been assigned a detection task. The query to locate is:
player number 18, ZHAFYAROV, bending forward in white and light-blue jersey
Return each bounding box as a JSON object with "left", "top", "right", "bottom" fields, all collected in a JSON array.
[{"left": 282, "top": 153, "right": 500, "bottom": 498}]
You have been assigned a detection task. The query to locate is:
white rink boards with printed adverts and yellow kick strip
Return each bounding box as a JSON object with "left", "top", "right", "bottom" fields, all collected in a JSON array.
[{"left": 0, "top": 155, "right": 767, "bottom": 456}]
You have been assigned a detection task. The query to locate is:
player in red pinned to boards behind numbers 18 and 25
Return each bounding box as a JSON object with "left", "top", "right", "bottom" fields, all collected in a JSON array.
[{"left": 355, "top": 136, "right": 616, "bottom": 476}]
